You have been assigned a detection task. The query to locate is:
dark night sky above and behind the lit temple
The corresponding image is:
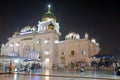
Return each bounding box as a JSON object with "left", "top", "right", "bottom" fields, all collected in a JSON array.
[{"left": 0, "top": 0, "right": 120, "bottom": 54}]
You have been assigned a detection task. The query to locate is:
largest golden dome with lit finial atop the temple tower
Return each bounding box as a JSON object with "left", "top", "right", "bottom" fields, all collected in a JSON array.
[{"left": 42, "top": 5, "right": 56, "bottom": 22}]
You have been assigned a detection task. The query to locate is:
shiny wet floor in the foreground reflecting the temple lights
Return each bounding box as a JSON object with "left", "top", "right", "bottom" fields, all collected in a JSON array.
[{"left": 0, "top": 70, "right": 120, "bottom": 80}]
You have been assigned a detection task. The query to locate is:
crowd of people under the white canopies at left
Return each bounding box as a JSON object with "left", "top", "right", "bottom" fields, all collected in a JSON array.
[{"left": 0, "top": 62, "right": 42, "bottom": 73}]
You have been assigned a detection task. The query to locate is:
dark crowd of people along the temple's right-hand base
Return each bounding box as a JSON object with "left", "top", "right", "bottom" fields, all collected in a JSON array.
[{"left": 52, "top": 60, "right": 120, "bottom": 72}]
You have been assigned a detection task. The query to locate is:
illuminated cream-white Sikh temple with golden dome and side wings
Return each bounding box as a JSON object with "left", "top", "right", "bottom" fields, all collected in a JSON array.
[{"left": 0, "top": 5, "right": 100, "bottom": 68}]
